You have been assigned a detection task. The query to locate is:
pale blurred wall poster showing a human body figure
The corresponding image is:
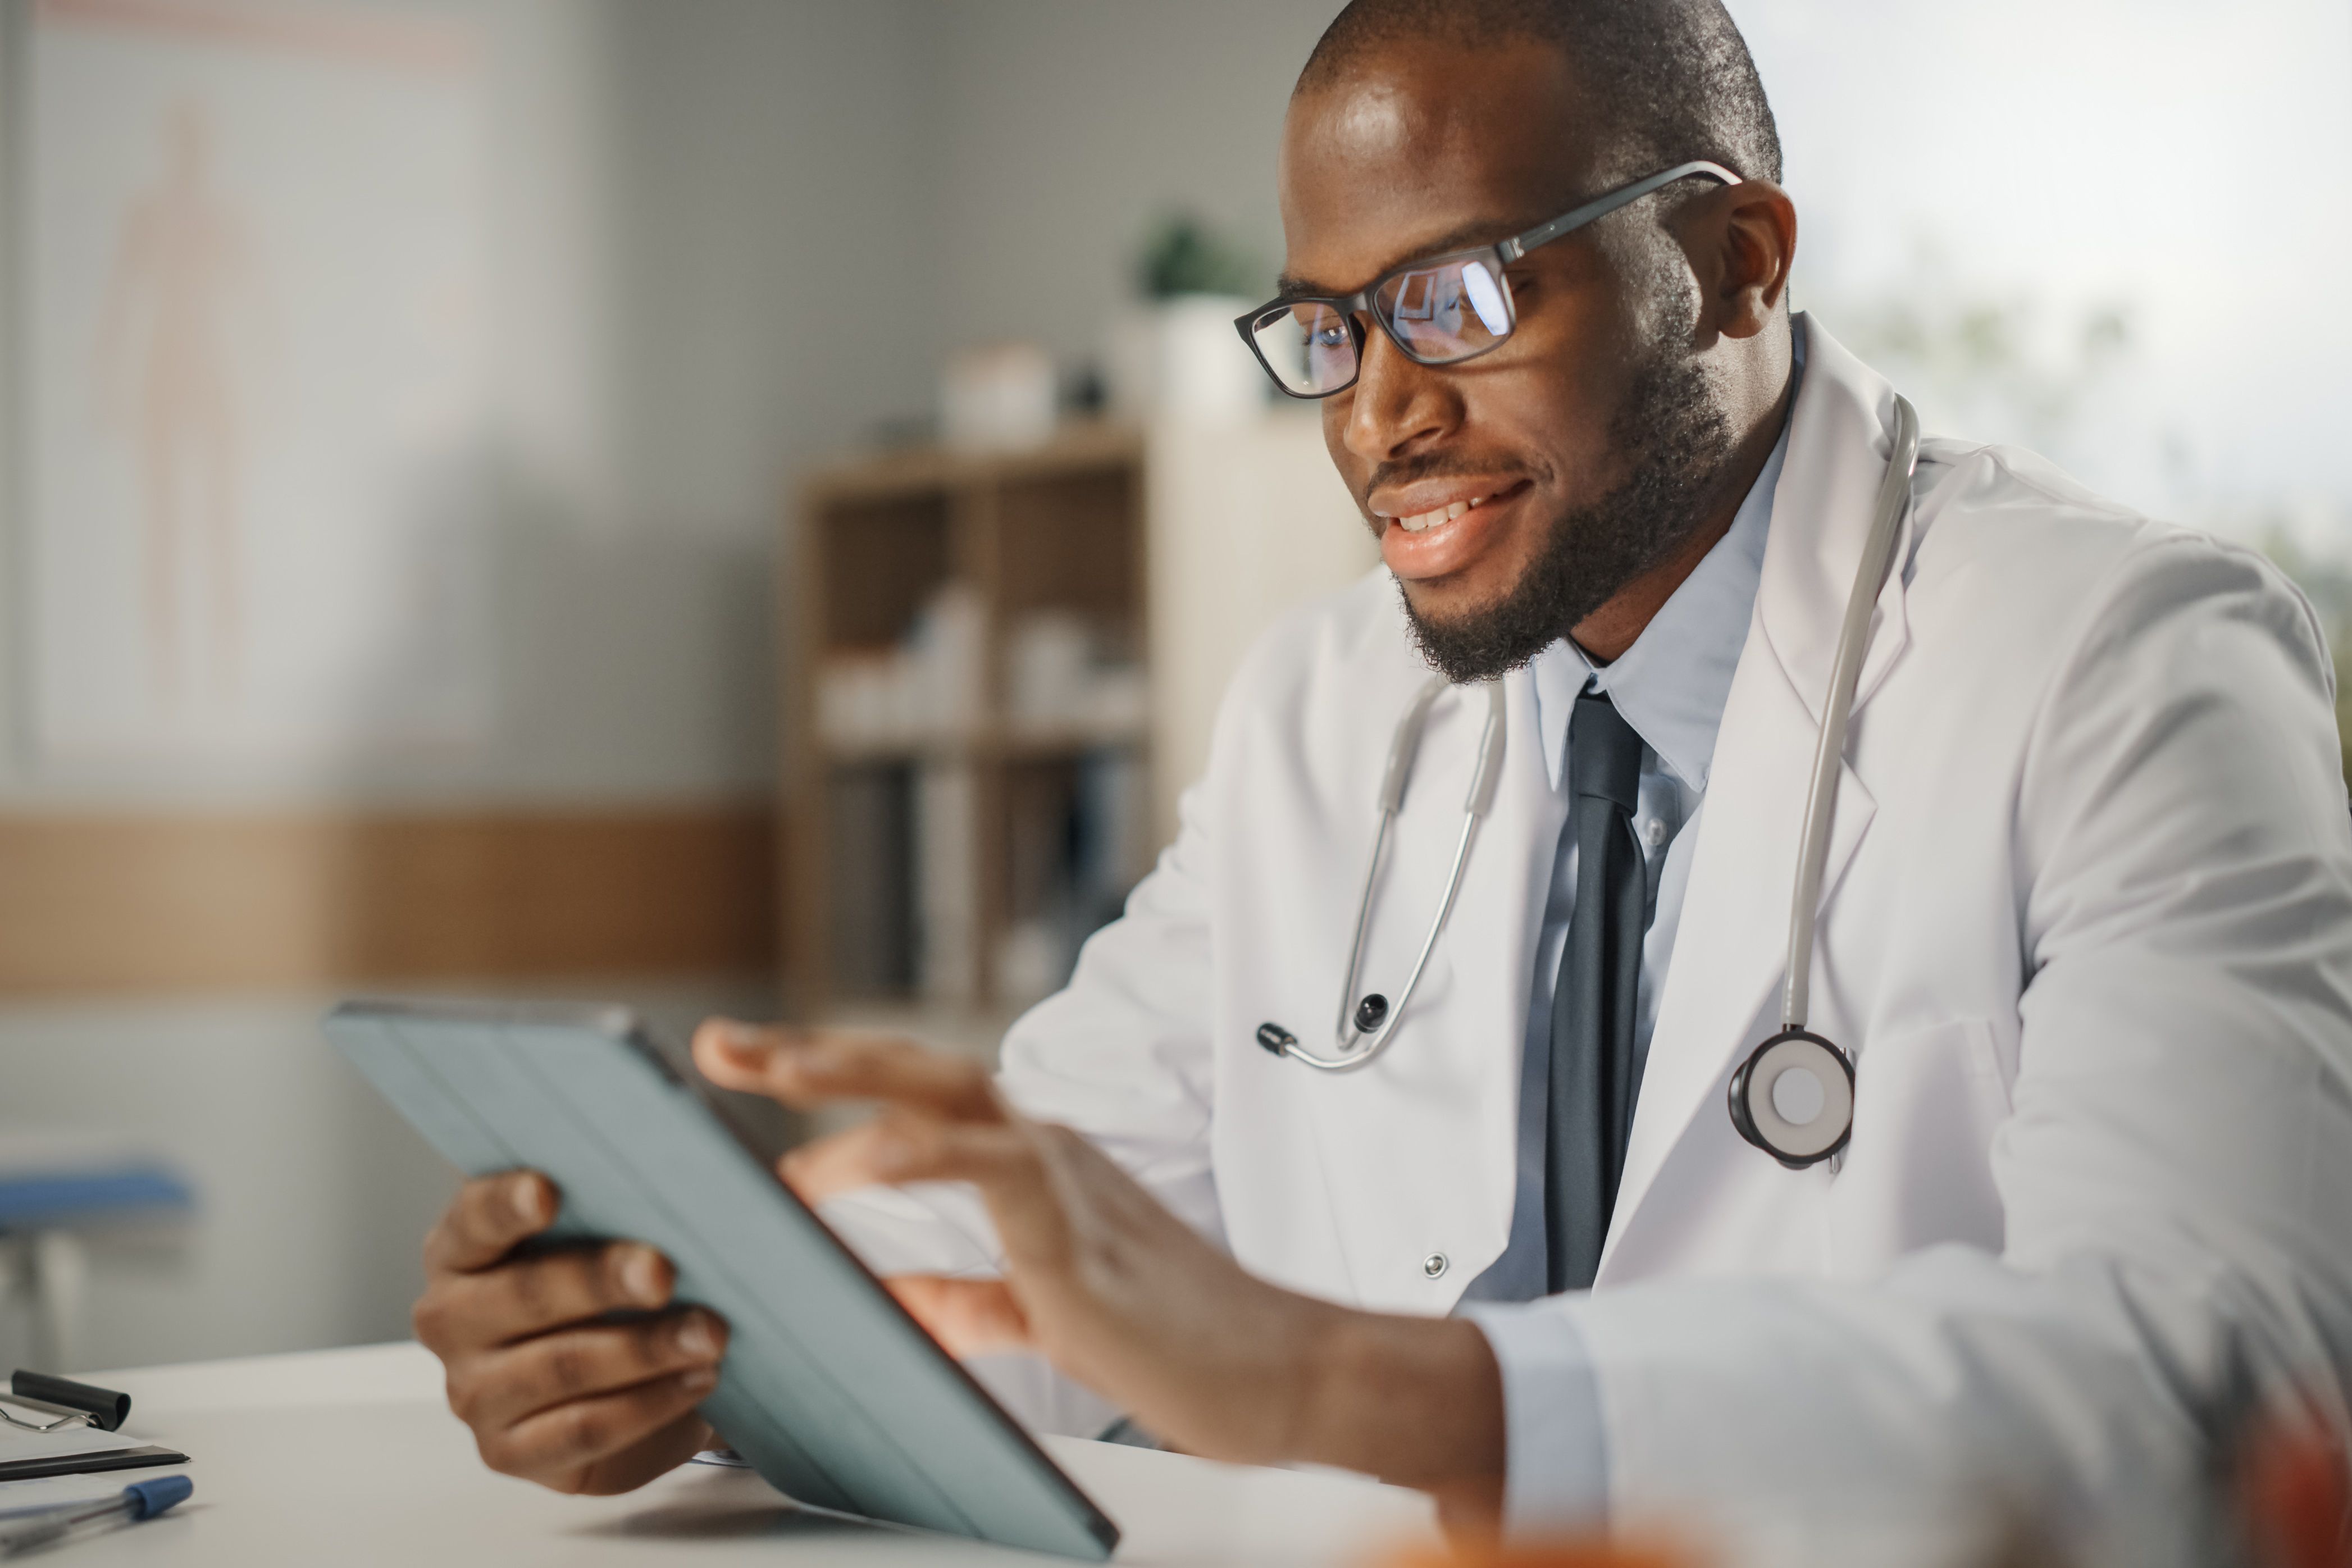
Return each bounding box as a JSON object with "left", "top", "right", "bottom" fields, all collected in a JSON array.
[{"left": 19, "top": 0, "right": 494, "bottom": 773}]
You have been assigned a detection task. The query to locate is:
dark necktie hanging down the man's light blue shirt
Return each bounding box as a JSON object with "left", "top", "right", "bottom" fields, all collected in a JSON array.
[{"left": 1543, "top": 691, "right": 1649, "bottom": 1293}]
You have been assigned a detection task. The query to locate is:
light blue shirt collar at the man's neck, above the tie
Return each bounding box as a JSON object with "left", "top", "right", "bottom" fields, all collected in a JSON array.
[{"left": 1531, "top": 381, "right": 1804, "bottom": 790}]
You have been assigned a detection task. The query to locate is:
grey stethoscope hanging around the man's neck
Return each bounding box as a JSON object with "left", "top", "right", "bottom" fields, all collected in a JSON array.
[{"left": 1259, "top": 397, "right": 1919, "bottom": 1171}]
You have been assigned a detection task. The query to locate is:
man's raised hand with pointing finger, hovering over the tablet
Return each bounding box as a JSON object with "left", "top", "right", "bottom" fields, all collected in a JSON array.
[{"left": 694, "top": 1020, "right": 1503, "bottom": 1512}]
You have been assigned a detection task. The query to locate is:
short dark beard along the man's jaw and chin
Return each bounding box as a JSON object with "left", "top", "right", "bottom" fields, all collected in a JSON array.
[{"left": 1397, "top": 345, "right": 1738, "bottom": 684}]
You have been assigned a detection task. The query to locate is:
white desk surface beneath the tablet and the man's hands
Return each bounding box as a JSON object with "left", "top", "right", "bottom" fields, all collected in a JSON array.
[{"left": 28, "top": 1344, "right": 1432, "bottom": 1568}]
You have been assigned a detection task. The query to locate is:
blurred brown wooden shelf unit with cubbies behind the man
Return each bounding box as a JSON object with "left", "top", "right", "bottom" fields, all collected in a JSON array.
[{"left": 781, "top": 423, "right": 1150, "bottom": 1015}]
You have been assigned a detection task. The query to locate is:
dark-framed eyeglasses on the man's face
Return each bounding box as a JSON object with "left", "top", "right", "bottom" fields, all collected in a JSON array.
[{"left": 1233, "top": 160, "right": 1740, "bottom": 397}]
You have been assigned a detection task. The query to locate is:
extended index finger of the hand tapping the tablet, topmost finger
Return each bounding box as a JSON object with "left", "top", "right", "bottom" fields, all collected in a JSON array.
[{"left": 694, "top": 1018, "right": 1004, "bottom": 1122}]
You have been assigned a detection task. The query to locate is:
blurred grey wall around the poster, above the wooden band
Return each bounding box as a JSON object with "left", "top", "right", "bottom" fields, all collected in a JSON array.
[{"left": 0, "top": 0, "right": 938, "bottom": 806}]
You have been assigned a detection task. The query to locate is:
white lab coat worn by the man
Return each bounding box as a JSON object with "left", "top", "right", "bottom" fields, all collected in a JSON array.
[{"left": 840, "top": 327, "right": 2352, "bottom": 1561}]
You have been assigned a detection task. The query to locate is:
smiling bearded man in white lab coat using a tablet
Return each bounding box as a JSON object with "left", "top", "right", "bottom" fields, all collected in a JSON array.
[{"left": 416, "top": 0, "right": 2352, "bottom": 1530}]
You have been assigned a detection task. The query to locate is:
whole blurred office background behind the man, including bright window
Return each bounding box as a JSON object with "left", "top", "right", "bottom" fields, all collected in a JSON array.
[{"left": 0, "top": 0, "right": 2352, "bottom": 1370}]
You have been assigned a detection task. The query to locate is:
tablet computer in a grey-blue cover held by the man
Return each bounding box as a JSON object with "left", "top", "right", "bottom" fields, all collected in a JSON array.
[{"left": 327, "top": 1001, "right": 1119, "bottom": 1561}]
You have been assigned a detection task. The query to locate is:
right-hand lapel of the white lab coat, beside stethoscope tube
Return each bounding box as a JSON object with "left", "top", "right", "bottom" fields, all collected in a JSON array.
[{"left": 1599, "top": 322, "right": 1910, "bottom": 1279}]
